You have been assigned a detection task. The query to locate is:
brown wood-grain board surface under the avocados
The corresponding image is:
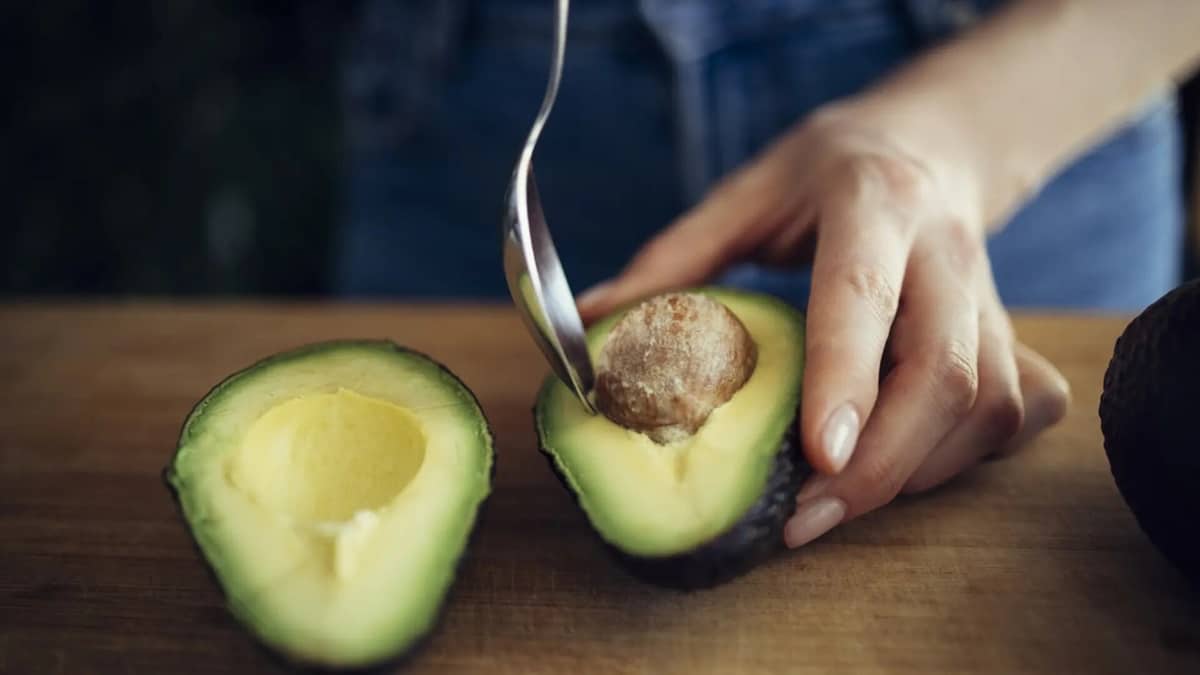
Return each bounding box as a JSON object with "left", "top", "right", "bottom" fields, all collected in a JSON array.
[{"left": 0, "top": 301, "right": 1200, "bottom": 675}]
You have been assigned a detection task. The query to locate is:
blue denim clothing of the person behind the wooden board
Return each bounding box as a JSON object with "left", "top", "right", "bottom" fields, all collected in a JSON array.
[{"left": 336, "top": 0, "right": 1183, "bottom": 310}]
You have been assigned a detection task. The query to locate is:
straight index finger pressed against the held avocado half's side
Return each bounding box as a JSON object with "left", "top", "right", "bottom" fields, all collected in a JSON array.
[{"left": 800, "top": 172, "right": 911, "bottom": 473}]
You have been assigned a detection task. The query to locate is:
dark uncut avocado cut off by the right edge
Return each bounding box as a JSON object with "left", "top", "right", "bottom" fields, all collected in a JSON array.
[{"left": 1099, "top": 280, "right": 1200, "bottom": 584}]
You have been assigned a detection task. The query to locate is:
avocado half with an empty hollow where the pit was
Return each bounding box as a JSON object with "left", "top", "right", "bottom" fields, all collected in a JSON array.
[{"left": 164, "top": 341, "right": 494, "bottom": 669}]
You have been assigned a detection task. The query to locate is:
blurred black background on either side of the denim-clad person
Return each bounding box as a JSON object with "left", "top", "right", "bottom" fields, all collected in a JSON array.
[{"left": 0, "top": 0, "right": 1200, "bottom": 295}]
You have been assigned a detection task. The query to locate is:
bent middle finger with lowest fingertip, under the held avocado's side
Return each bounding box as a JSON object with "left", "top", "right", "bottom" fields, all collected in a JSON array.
[{"left": 785, "top": 239, "right": 979, "bottom": 546}]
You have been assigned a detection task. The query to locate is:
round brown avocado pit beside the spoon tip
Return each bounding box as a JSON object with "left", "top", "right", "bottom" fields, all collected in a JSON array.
[{"left": 595, "top": 293, "right": 757, "bottom": 444}]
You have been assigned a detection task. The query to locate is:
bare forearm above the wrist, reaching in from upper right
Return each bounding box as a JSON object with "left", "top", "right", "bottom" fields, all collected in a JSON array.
[{"left": 856, "top": 0, "right": 1200, "bottom": 228}]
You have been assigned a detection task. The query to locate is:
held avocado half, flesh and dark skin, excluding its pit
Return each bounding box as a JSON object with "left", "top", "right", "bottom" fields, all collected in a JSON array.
[{"left": 534, "top": 288, "right": 811, "bottom": 589}]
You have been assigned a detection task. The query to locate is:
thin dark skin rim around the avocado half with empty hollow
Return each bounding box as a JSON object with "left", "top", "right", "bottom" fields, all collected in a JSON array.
[{"left": 160, "top": 339, "right": 498, "bottom": 675}]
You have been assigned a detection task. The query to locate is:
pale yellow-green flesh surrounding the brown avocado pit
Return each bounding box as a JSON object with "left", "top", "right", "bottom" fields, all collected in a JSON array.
[{"left": 538, "top": 289, "right": 804, "bottom": 556}]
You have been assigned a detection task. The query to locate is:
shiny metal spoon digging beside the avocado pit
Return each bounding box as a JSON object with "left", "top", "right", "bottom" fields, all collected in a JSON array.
[{"left": 500, "top": 0, "right": 595, "bottom": 414}]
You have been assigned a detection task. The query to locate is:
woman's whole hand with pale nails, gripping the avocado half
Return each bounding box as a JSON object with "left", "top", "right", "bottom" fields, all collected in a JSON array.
[{"left": 580, "top": 104, "right": 1068, "bottom": 546}]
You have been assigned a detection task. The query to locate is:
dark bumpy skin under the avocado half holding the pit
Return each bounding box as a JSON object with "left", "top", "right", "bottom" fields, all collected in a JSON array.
[{"left": 534, "top": 408, "right": 812, "bottom": 591}]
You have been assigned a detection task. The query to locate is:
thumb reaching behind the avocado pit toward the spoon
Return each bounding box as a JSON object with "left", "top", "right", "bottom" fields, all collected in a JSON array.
[{"left": 577, "top": 161, "right": 802, "bottom": 323}]
